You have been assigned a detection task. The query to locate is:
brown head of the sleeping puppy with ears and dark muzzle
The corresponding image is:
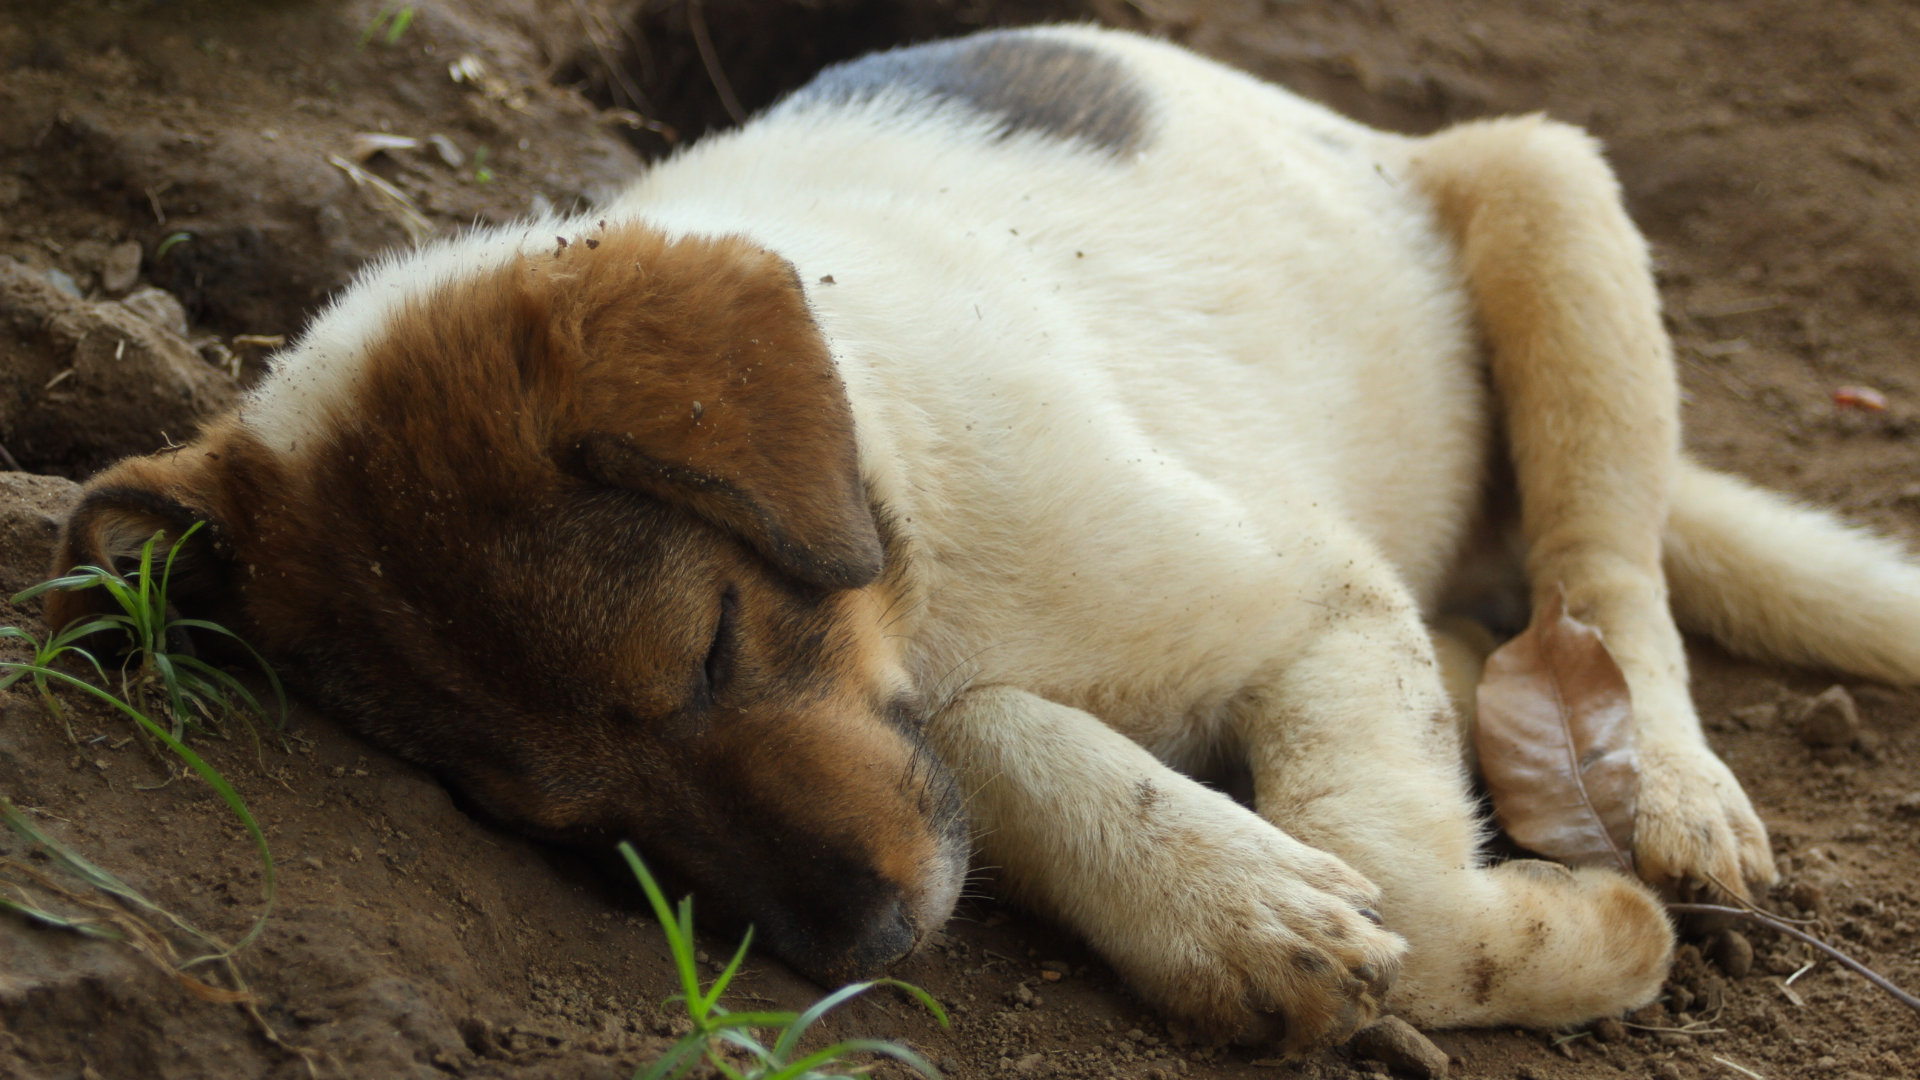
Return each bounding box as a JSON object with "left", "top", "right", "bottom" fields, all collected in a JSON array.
[{"left": 48, "top": 227, "right": 964, "bottom": 980}]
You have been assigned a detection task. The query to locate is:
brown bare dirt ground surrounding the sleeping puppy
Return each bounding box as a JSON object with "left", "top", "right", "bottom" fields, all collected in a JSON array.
[{"left": 0, "top": 0, "right": 1920, "bottom": 1080}]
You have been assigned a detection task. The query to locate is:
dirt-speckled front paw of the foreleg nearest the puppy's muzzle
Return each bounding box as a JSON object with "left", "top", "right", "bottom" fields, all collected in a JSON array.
[{"left": 1104, "top": 821, "right": 1405, "bottom": 1051}]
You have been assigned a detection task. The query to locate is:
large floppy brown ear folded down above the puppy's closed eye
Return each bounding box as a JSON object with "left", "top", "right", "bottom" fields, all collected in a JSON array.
[{"left": 532, "top": 227, "right": 883, "bottom": 588}]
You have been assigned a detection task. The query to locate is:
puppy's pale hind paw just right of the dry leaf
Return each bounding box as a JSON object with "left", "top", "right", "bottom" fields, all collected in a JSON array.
[{"left": 1634, "top": 746, "right": 1778, "bottom": 899}]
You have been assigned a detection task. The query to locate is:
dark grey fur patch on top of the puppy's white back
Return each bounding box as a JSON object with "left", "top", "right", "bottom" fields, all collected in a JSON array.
[{"left": 789, "top": 31, "right": 1146, "bottom": 154}]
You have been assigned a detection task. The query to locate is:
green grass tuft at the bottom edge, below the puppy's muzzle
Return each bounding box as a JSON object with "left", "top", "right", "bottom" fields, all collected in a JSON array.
[{"left": 620, "top": 842, "right": 947, "bottom": 1080}]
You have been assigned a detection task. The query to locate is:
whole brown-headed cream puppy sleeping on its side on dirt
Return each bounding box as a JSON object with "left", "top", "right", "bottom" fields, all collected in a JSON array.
[{"left": 48, "top": 29, "right": 1920, "bottom": 1047}]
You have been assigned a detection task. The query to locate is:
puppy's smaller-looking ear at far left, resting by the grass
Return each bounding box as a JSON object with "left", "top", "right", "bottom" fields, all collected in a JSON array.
[{"left": 46, "top": 450, "right": 232, "bottom": 632}]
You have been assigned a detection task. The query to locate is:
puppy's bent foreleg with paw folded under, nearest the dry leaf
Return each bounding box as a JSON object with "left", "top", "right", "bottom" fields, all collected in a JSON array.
[{"left": 1235, "top": 523, "right": 1672, "bottom": 1026}]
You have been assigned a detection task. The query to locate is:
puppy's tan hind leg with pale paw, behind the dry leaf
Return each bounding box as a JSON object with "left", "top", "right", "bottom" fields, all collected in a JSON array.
[{"left": 1407, "top": 117, "right": 1774, "bottom": 894}]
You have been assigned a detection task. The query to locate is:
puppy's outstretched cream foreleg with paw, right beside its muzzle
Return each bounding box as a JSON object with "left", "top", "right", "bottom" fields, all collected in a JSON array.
[{"left": 929, "top": 686, "right": 1404, "bottom": 1047}]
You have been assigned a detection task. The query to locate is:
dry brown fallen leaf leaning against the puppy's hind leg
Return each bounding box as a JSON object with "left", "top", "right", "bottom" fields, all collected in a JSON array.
[{"left": 1475, "top": 590, "right": 1640, "bottom": 874}]
